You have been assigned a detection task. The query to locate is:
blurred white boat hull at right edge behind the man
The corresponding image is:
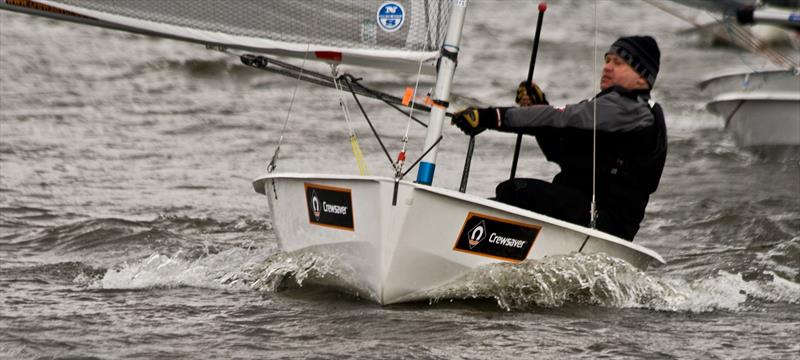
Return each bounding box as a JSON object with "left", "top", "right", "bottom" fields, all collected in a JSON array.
[{"left": 699, "top": 70, "right": 800, "bottom": 148}]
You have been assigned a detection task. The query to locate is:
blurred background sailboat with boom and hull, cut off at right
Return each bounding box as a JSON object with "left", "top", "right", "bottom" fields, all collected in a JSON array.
[{"left": 651, "top": 0, "right": 800, "bottom": 153}]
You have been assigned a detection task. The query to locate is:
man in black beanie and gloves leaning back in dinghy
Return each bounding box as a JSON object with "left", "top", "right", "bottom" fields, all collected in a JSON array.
[{"left": 453, "top": 36, "right": 667, "bottom": 241}]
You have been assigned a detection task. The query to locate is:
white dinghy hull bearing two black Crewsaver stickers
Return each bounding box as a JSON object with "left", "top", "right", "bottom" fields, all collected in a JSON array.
[{"left": 253, "top": 174, "right": 664, "bottom": 304}]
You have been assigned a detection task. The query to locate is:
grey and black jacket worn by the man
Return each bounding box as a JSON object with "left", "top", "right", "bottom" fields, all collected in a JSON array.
[{"left": 497, "top": 87, "right": 667, "bottom": 239}]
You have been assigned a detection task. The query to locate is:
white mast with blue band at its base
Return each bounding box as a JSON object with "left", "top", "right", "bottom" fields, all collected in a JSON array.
[{"left": 417, "top": 0, "right": 468, "bottom": 185}]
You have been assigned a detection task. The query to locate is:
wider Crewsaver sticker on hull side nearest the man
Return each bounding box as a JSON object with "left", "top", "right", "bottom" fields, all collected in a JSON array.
[{"left": 453, "top": 212, "right": 542, "bottom": 263}]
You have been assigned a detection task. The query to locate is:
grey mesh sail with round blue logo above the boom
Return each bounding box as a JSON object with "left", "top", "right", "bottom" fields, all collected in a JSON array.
[{"left": 2, "top": 0, "right": 451, "bottom": 70}]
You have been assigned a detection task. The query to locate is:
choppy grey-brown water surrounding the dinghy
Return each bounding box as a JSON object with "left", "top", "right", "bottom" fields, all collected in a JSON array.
[{"left": 0, "top": 1, "right": 800, "bottom": 359}]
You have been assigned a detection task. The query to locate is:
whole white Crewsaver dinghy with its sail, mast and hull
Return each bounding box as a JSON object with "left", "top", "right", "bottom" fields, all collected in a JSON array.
[{"left": 0, "top": 0, "right": 664, "bottom": 304}]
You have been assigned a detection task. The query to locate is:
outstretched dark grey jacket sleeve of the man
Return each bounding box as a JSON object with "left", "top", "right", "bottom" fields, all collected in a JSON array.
[{"left": 498, "top": 92, "right": 655, "bottom": 134}]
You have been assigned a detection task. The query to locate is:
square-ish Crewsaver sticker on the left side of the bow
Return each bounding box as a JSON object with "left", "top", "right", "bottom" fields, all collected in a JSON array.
[{"left": 303, "top": 183, "right": 355, "bottom": 231}]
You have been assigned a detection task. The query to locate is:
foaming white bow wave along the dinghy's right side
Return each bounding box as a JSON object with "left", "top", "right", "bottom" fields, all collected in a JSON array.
[{"left": 430, "top": 254, "right": 800, "bottom": 312}]
